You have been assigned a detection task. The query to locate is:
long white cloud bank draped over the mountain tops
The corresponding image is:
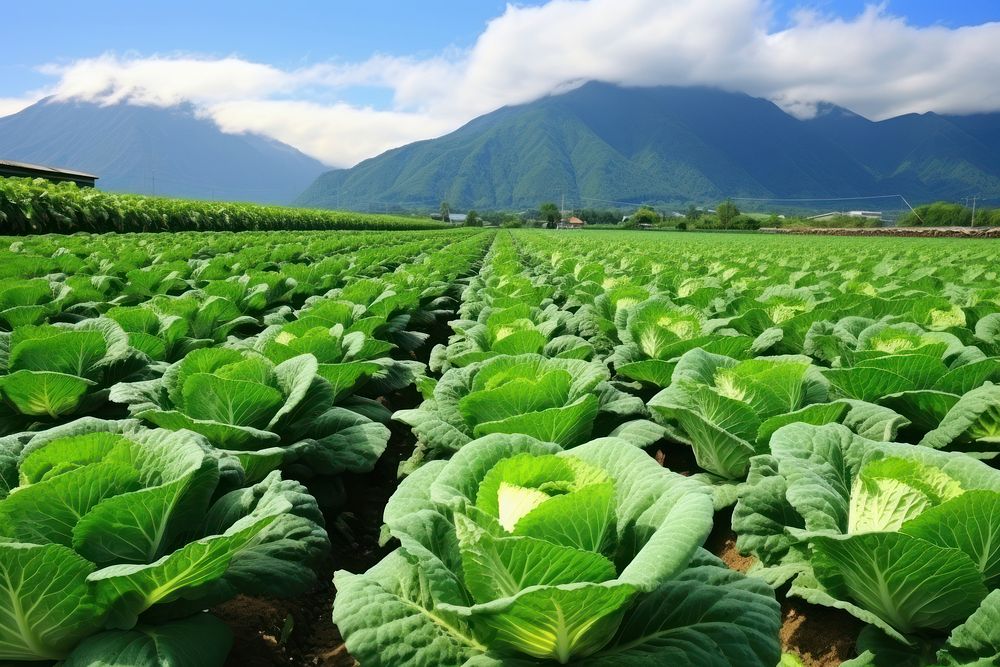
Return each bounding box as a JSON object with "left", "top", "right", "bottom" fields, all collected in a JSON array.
[{"left": 23, "top": 0, "right": 1000, "bottom": 166}]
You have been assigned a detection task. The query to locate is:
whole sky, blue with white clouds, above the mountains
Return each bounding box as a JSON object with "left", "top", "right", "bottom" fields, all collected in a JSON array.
[{"left": 0, "top": 0, "right": 1000, "bottom": 166}]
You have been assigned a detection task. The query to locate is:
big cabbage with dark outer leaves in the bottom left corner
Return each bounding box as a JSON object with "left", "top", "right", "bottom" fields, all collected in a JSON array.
[{"left": 0, "top": 418, "right": 329, "bottom": 665}]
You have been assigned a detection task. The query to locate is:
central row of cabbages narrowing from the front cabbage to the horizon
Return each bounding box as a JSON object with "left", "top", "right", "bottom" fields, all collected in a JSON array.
[{"left": 334, "top": 234, "right": 780, "bottom": 667}]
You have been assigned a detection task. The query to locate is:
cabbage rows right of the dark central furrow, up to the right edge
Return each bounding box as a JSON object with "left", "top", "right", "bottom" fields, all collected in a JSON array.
[{"left": 335, "top": 232, "right": 1000, "bottom": 665}]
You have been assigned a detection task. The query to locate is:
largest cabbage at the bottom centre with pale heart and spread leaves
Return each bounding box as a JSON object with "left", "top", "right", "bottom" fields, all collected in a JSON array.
[{"left": 334, "top": 434, "right": 779, "bottom": 667}]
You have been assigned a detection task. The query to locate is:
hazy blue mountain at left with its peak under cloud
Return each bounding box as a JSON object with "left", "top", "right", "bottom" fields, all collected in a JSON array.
[{"left": 0, "top": 99, "right": 327, "bottom": 204}]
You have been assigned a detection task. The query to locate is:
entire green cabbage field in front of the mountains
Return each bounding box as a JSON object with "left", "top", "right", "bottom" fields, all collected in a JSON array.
[{"left": 0, "top": 227, "right": 1000, "bottom": 667}]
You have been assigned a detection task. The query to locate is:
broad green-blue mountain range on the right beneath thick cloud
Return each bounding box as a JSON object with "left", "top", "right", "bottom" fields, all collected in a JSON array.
[{"left": 297, "top": 82, "right": 1000, "bottom": 209}]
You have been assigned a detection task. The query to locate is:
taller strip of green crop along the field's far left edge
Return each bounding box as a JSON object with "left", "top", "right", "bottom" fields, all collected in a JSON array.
[{"left": 0, "top": 178, "right": 445, "bottom": 234}]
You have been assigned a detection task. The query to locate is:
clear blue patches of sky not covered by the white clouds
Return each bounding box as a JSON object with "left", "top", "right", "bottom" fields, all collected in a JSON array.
[{"left": 0, "top": 0, "right": 1000, "bottom": 103}]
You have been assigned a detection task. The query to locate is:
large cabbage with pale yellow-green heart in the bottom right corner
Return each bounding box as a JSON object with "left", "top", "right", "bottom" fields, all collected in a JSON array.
[{"left": 733, "top": 424, "right": 1000, "bottom": 664}]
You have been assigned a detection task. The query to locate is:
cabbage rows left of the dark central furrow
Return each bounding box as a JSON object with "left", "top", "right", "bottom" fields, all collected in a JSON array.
[{"left": 0, "top": 228, "right": 489, "bottom": 665}]
